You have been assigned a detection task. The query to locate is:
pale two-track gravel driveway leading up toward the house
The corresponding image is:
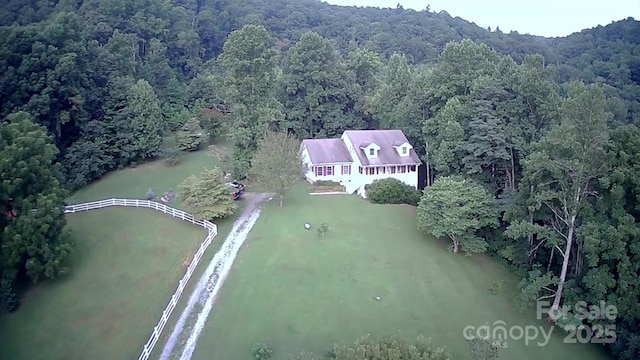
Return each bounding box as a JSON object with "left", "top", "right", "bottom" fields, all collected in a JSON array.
[{"left": 160, "top": 193, "right": 273, "bottom": 360}]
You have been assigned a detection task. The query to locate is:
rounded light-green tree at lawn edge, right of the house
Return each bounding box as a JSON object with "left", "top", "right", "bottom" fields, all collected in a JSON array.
[{"left": 417, "top": 177, "right": 498, "bottom": 254}]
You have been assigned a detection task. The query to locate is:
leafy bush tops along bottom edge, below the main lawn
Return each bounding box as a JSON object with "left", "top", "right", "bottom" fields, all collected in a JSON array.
[{"left": 334, "top": 335, "right": 451, "bottom": 360}]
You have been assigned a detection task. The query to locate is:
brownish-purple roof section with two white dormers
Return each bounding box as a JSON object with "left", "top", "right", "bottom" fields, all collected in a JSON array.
[{"left": 344, "top": 130, "right": 422, "bottom": 166}]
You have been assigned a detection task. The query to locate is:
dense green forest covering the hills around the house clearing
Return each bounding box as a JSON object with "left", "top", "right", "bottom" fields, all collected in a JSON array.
[{"left": 0, "top": 0, "right": 640, "bottom": 359}]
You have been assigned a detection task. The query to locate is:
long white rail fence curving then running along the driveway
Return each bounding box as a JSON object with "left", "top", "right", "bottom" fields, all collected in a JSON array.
[{"left": 64, "top": 199, "right": 218, "bottom": 360}]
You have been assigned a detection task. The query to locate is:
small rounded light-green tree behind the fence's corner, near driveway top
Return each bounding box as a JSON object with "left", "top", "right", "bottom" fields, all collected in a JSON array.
[{"left": 178, "top": 168, "right": 238, "bottom": 220}]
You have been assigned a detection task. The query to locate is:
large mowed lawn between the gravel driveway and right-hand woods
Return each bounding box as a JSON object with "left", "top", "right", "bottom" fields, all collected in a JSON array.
[{"left": 193, "top": 186, "right": 606, "bottom": 360}]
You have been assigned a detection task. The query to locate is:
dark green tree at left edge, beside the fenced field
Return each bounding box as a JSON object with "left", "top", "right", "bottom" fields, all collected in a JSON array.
[{"left": 0, "top": 112, "right": 72, "bottom": 292}]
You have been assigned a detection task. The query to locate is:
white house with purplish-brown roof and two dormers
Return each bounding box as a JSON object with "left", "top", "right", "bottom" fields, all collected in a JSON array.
[{"left": 301, "top": 130, "right": 421, "bottom": 197}]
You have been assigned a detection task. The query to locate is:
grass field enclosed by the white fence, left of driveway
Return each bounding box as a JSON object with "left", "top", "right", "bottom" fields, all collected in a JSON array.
[{"left": 0, "top": 208, "right": 205, "bottom": 360}]
